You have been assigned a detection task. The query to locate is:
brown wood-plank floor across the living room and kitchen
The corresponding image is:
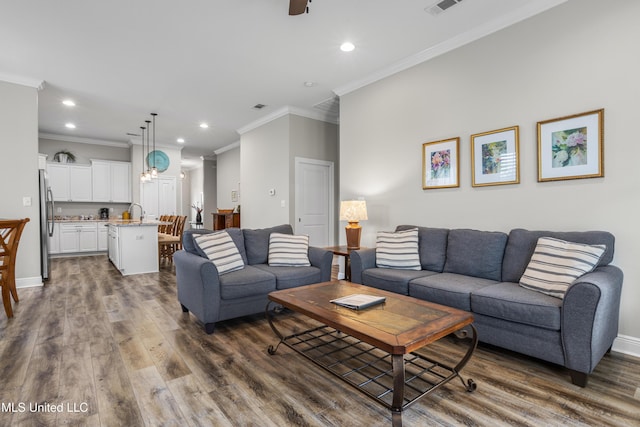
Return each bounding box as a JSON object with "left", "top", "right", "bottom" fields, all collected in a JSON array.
[{"left": 0, "top": 256, "right": 640, "bottom": 427}]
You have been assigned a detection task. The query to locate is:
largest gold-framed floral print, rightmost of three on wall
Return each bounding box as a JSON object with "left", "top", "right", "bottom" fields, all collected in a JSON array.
[{"left": 538, "top": 109, "right": 604, "bottom": 182}]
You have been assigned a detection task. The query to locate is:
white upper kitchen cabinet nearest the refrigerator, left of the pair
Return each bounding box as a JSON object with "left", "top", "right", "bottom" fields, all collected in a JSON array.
[{"left": 47, "top": 163, "right": 93, "bottom": 202}]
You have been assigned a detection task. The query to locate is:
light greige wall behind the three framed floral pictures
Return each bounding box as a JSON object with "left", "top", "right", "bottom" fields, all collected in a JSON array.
[{"left": 340, "top": 0, "right": 640, "bottom": 348}]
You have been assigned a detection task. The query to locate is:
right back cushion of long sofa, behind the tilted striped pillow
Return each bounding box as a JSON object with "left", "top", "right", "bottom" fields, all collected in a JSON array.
[{"left": 502, "top": 228, "right": 615, "bottom": 283}]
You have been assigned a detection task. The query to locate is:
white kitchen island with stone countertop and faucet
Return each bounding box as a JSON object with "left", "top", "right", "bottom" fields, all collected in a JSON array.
[{"left": 107, "top": 220, "right": 162, "bottom": 276}]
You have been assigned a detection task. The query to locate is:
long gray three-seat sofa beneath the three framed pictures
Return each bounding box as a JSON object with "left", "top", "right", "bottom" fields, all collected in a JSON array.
[{"left": 351, "top": 225, "right": 623, "bottom": 387}]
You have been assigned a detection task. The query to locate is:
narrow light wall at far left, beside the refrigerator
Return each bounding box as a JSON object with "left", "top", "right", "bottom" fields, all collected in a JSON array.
[{"left": 0, "top": 81, "right": 42, "bottom": 286}]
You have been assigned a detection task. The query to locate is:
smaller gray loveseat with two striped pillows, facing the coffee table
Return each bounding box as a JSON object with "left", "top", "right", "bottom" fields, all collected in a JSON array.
[{"left": 173, "top": 224, "right": 333, "bottom": 334}]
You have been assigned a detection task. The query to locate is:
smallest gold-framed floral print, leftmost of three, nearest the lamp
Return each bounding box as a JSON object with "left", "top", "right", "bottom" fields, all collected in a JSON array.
[{"left": 422, "top": 137, "right": 460, "bottom": 190}]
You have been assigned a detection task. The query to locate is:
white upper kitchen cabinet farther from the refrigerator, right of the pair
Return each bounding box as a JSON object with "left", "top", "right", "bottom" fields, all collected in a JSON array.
[{"left": 91, "top": 160, "right": 131, "bottom": 203}]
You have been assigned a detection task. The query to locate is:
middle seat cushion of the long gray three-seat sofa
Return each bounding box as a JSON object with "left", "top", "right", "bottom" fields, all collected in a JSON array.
[{"left": 409, "top": 273, "right": 497, "bottom": 311}]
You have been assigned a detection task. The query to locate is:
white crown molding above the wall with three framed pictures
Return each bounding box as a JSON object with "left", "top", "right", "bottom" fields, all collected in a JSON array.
[{"left": 334, "top": 0, "right": 568, "bottom": 96}]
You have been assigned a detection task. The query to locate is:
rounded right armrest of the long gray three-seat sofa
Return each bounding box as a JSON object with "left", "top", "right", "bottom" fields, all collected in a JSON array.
[{"left": 561, "top": 265, "right": 623, "bottom": 374}]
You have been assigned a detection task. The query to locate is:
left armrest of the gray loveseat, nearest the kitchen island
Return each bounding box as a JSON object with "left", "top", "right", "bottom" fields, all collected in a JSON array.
[{"left": 173, "top": 250, "right": 221, "bottom": 324}]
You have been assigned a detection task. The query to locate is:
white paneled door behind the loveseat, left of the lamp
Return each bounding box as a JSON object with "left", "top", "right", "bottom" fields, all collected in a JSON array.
[{"left": 295, "top": 157, "right": 334, "bottom": 246}]
